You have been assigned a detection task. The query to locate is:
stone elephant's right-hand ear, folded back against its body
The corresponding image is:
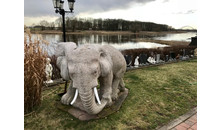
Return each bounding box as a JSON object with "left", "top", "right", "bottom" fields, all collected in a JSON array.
[{"left": 99, "top": 47, "right": 112, "bottom": 76}]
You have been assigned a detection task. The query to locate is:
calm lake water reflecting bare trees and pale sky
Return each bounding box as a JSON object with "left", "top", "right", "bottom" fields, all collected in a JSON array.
[{"left": 29, "top": 32, "right": 197, "bottom": 55}]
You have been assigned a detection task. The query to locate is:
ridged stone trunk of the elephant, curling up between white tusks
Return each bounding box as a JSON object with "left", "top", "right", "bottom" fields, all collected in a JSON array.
[{"left": 79, "top": 89, "right": 107, "bottom": 114}]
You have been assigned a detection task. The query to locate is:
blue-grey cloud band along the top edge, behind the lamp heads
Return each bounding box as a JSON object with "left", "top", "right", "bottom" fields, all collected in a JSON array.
[{"left": 24, "top": 0, "right": 155, "bottom": 17}]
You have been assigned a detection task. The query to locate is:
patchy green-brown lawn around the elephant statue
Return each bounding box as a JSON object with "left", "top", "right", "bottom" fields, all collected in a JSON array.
[{"left": 24, "top": 59, "right": 197, "bottom": 130}]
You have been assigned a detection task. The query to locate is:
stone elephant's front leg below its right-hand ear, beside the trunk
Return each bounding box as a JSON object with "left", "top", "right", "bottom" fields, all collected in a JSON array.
[{"left": 99, "top": 72, "right": 113, "bottom": 106}]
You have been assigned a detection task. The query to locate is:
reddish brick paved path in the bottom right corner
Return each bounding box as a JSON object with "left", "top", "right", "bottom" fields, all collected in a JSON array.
[{"left": 156, "top": 107, "right": 197, "bottom": 130}]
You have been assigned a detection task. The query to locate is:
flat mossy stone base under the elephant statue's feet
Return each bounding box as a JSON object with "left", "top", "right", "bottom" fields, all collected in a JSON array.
[{"left": 56, "top": 88, "right": 129, "bottom": 121}]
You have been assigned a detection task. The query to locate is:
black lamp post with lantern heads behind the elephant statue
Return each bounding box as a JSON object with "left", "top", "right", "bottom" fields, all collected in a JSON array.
[{"left": 52, "top": 0, "right": 75, "bottom": 95}]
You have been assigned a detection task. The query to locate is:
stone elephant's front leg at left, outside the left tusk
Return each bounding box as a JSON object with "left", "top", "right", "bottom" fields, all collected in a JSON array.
[{"left": 61, "top": 81, "right": 76, "bottom": 105}]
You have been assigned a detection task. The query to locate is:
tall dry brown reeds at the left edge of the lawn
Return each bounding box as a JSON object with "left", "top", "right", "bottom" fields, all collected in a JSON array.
[{"left": 24, "top": 29, "right": 49, "bottom": 113}]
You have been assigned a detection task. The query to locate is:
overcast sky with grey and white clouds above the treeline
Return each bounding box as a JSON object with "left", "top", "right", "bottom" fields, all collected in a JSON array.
[{"left": 24, "top": 0, "right": 197, "bottom": 29}]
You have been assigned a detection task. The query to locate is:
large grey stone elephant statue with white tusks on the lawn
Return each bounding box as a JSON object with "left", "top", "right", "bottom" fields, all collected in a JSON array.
[{"left": 55, "top": 42, "right": 126, "bottom": 114}]
